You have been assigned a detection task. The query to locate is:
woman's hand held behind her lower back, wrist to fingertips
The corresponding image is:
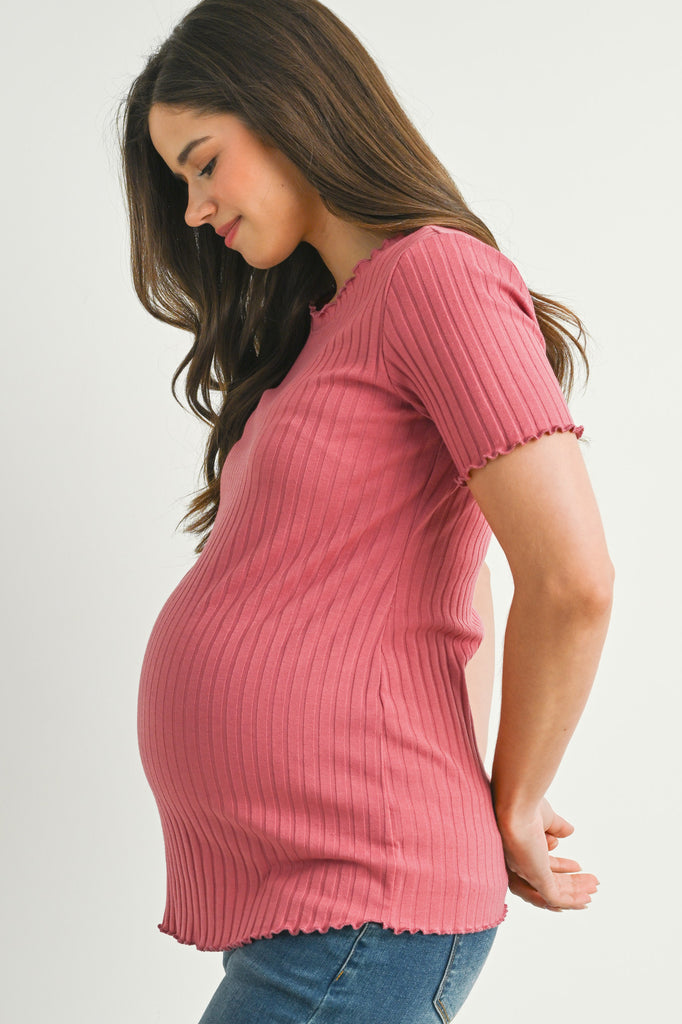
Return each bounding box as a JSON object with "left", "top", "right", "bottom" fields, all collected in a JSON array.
[{"left": 498, "top": 798, "right": 599, "bottom": 911}]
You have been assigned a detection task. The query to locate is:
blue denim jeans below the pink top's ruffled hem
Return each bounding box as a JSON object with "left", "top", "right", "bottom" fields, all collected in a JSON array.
[{"left": 195, "top": 922, "right": 498, "bottom": 1024}]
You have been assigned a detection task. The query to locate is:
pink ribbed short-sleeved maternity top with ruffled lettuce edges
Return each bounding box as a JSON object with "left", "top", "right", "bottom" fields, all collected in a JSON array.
[{"left": 138, "top": 225, "right": 584, "bottom": 950}]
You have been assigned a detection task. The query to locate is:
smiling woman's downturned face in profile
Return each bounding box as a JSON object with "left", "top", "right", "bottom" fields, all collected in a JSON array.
[{"left": 148, "top": 103, "right": 329, "bottom": 269}]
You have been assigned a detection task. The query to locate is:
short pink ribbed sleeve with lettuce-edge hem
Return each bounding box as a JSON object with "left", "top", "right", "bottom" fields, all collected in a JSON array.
[{"left": 382, "top": 225, "right": 584, "bottom": 485}]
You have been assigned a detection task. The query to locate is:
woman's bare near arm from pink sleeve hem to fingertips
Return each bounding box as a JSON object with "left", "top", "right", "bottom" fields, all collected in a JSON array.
[{"left": 468, "top": 431, "right": 614, "bottom": 910}]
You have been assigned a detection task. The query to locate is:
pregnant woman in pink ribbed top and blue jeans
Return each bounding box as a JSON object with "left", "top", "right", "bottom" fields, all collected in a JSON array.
[{"left": 115, "top": 0, "right": 613, "bottom": 1024}]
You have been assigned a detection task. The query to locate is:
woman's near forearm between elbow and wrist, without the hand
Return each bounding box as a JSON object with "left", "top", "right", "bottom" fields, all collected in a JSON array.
[{"left": 491, "top": 585, "right": 611, "bottom": 824}]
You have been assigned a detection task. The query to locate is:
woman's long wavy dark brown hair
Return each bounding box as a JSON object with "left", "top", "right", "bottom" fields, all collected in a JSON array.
[{"left": 112, "top": 0, "right": 589, "bottom": 554}]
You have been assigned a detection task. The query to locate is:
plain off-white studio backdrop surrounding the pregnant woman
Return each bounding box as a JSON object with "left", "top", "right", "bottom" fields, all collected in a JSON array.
[{"left": 0, "top": 0, "right": 682, "bottom": 1024}]
